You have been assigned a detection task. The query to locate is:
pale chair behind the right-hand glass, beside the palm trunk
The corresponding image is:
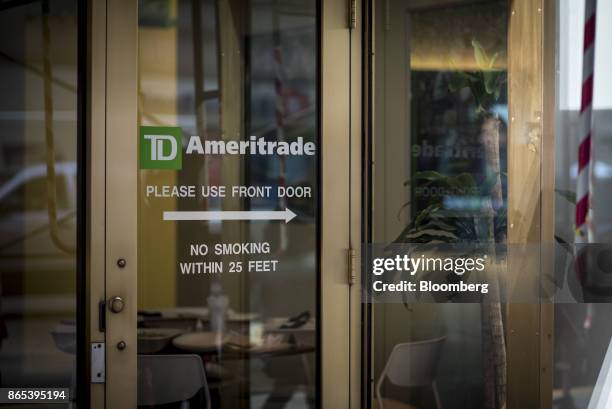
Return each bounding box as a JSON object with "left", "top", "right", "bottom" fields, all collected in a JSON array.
[{"left": 376, "top": 337, "right": 446, "bottom": 409}]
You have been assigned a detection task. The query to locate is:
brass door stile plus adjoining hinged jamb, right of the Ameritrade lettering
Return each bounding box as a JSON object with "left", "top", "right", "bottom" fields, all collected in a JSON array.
[{"left": 320, "top": 0, "right": 363, "bottom": 408}]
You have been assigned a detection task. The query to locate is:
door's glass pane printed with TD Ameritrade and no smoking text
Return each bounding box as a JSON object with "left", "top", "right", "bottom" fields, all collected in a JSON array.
[{"left": 138, "top": 0, "right": 319, "bottom": 408}]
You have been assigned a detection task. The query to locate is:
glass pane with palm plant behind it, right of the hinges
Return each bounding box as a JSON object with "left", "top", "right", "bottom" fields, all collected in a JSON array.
[{"left": 370, "top": 0, "right": 509, "bottom": 409}]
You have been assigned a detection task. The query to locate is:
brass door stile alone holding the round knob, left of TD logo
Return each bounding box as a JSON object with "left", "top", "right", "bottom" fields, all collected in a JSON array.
[{"left": 106, "top": 0, "right": 138, "bottom": 408}]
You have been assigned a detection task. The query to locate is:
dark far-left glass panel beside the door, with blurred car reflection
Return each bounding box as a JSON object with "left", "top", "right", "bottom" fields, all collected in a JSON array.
[{"left": 0, "top": 1, "right": 79, "bottom": 407}]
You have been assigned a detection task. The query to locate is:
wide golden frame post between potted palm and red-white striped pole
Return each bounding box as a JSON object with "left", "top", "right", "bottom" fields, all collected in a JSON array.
[{"left": 506, "top": 0, "right": 557, "bottom": 409}]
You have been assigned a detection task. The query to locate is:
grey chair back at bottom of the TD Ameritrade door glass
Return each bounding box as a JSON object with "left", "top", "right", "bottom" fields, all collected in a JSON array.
[{"left": 138, "top": 355, "right": 211, "bottom": 409}]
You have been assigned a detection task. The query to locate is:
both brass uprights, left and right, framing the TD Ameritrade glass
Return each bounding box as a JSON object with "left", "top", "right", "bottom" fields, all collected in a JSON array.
[{"left": 88, "top": 0, "right": 361, "bottom": 409}]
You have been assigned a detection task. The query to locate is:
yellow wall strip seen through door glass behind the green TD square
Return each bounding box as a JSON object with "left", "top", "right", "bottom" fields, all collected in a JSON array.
[{"left": 138, "top": 2, "right": 178, "bottom": 309}]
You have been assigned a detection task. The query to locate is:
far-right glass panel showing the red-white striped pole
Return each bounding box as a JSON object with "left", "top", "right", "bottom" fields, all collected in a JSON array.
[{"left": 552, "top": 0, "right": 612, "bottom": 409}]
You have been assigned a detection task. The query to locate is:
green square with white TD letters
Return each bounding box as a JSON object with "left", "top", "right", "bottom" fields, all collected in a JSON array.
[{"left": 139, "top": 126, "right": 183, "bottom": 170}]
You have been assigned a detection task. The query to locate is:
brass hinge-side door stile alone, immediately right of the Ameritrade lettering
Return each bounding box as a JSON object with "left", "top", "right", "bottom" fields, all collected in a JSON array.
[{"left": 319, "top": 1, "right": 351, "bottom": 408}]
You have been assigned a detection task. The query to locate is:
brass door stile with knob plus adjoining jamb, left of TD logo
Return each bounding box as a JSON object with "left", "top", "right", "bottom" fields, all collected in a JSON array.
[{"left": 87, "top": 0, "right": 138, "bottom": 409}]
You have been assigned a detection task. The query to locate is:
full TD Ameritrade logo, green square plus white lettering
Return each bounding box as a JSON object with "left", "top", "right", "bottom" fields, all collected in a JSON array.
[{"left": 140, "top": 126, "right": 316, "bottom": 170}]
